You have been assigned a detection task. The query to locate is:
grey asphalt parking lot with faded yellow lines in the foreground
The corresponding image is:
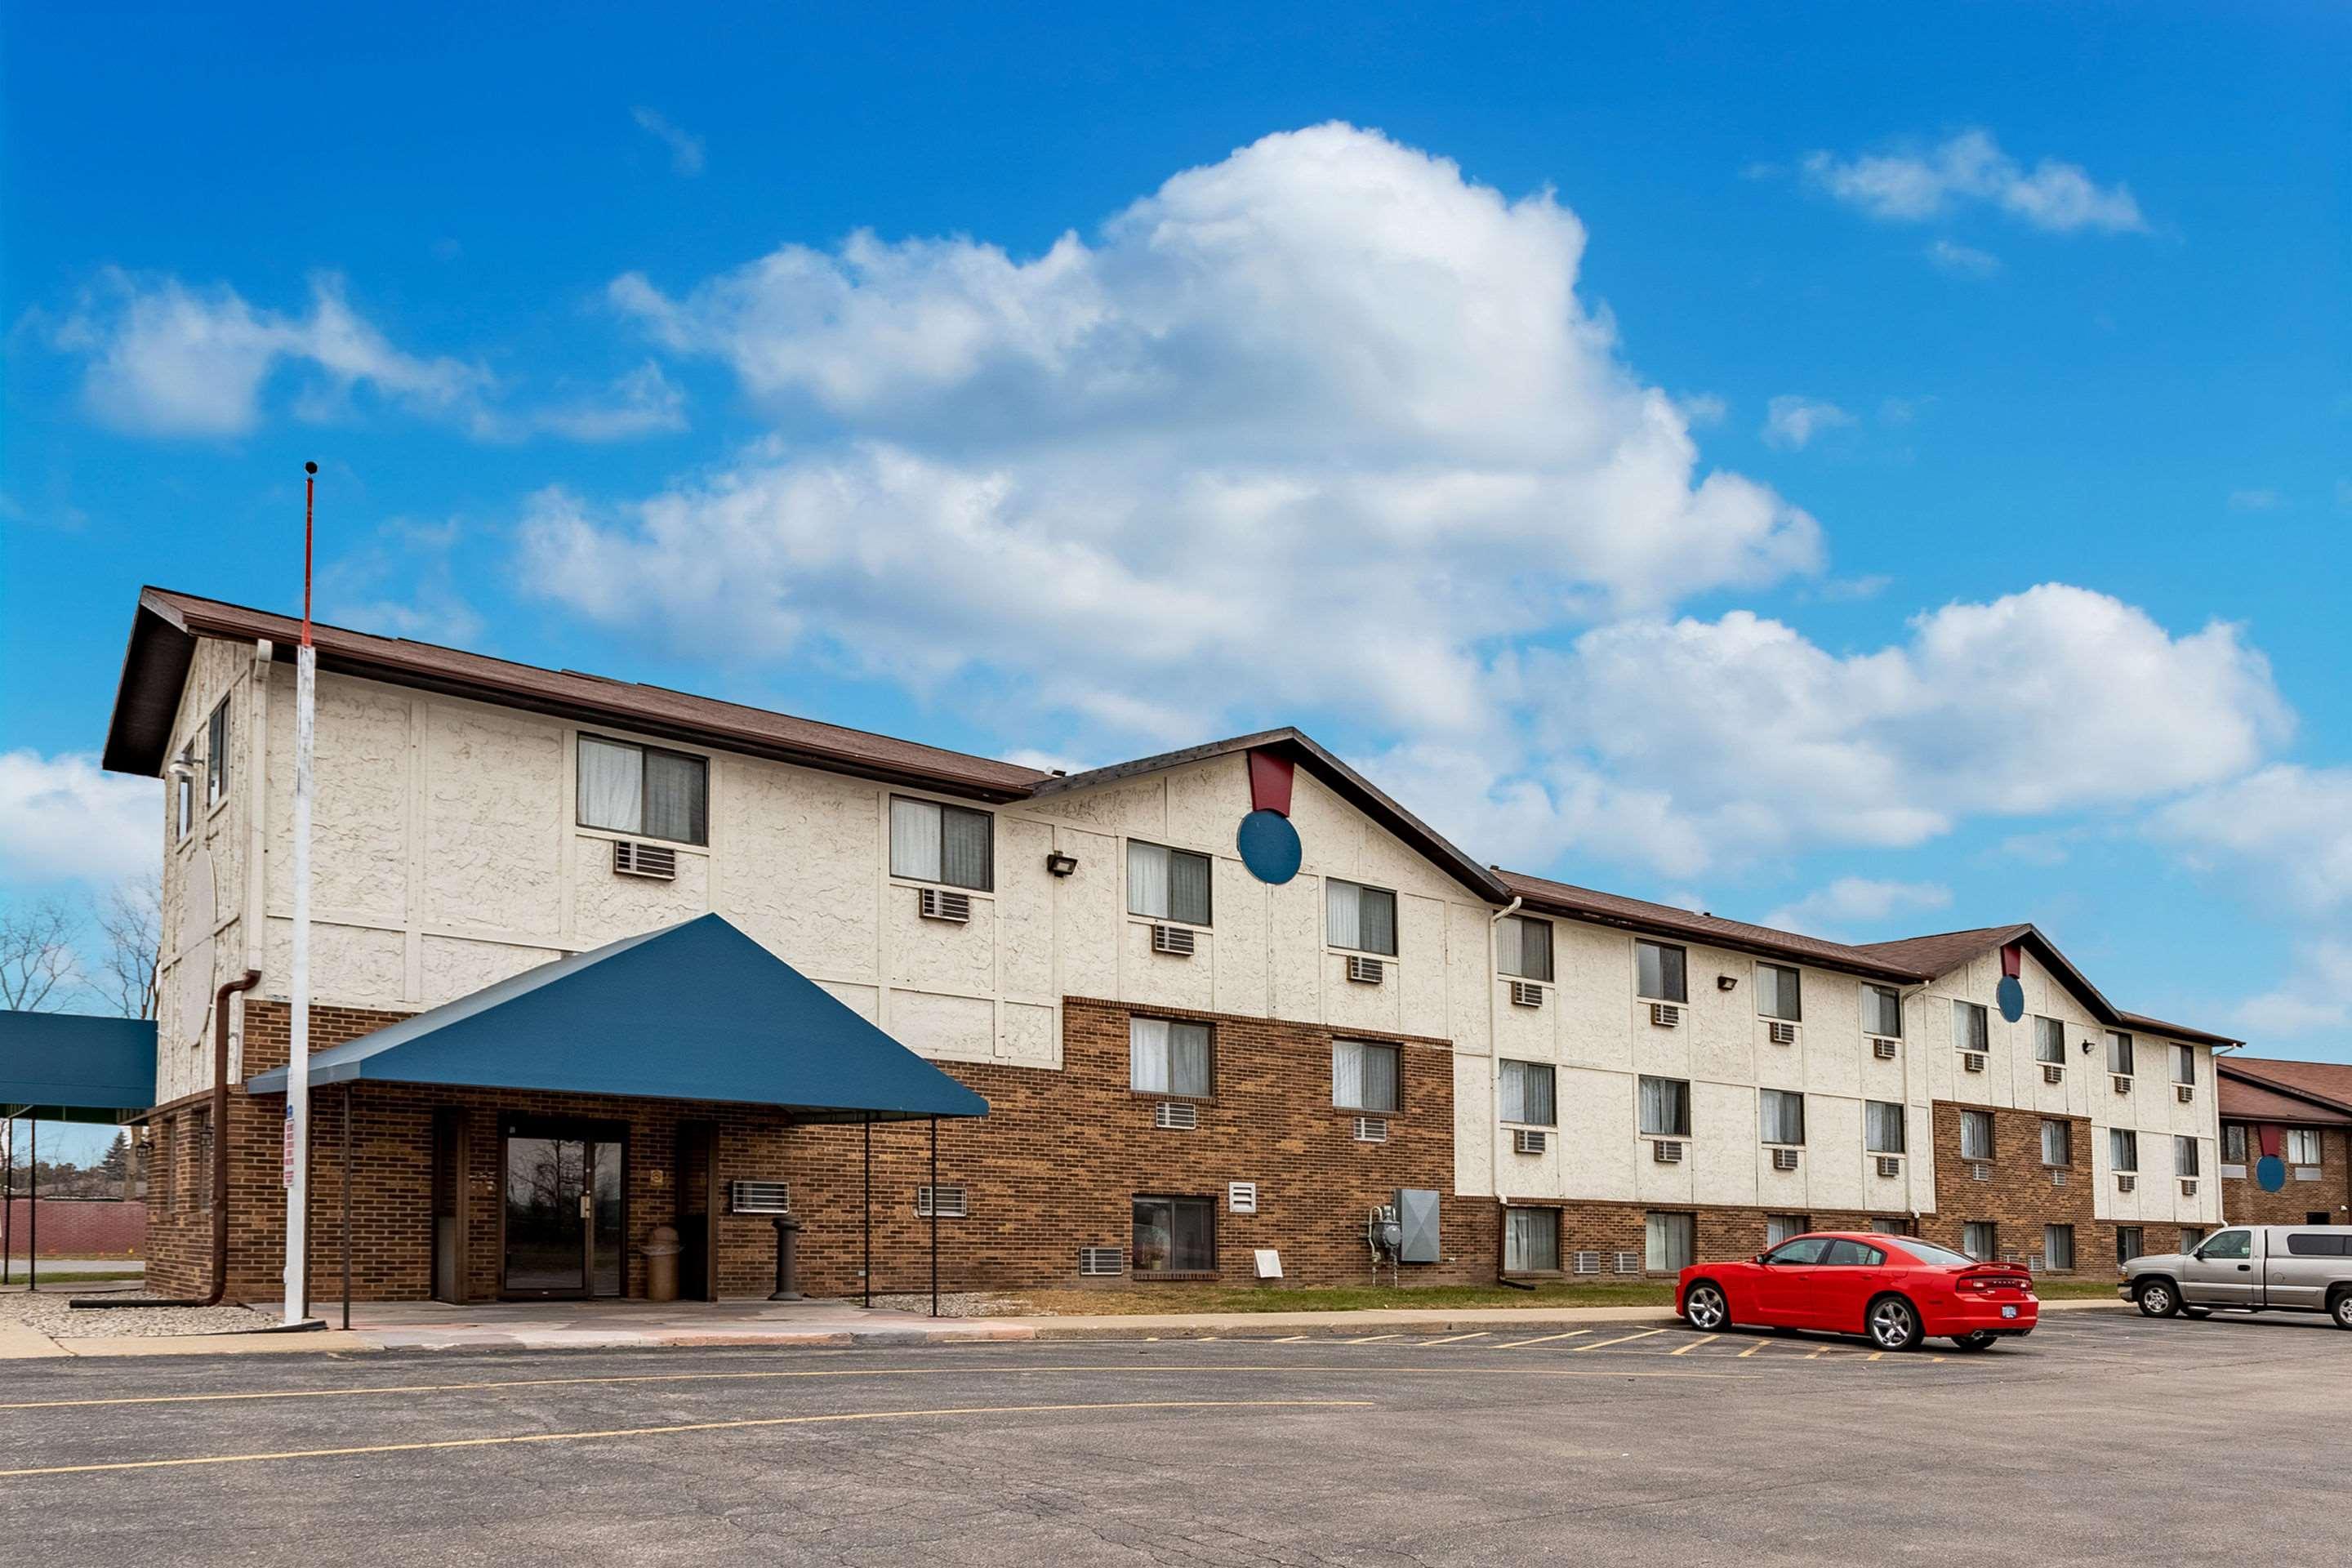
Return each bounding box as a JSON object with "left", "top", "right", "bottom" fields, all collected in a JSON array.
[{"left": 0, "top": 1312, "right": 2352, "bottom": 1568}]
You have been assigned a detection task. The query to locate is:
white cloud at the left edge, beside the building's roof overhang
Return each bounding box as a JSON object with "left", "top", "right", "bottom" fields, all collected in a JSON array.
[{"left": 0, "top": 750, "right": 163, "bottom": 884}]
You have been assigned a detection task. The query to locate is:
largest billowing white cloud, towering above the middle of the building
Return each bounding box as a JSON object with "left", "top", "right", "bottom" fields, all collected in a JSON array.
[{"left": 541, "top": 125, "right": 1820, "bottom": 738}]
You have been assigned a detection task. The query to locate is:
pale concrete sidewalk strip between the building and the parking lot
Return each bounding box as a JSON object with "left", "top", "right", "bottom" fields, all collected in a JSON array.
[{"left": 0, "top": 1300, "right": 2128, "bottom": 1361}]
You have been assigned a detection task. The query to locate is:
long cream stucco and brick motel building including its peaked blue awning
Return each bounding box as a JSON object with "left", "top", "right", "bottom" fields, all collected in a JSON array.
[{"left": 106, "top": 590, "right": 2237, "bottom": 1300}]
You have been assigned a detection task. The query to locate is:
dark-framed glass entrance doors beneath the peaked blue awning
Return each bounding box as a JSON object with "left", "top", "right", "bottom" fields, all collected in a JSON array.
[{"left": 499, "top": 1116, "right": 628, "bottom": 1298}]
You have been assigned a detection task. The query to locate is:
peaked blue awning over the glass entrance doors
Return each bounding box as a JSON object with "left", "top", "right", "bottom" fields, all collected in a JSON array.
[{"left": 245, "top": 915, "right": 988, "bottom": 1121}]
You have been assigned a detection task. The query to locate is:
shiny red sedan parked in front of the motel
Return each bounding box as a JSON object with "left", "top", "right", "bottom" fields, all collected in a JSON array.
[{"left": 1675, "top": 1232, "right": 2042, "bottom": 1349}]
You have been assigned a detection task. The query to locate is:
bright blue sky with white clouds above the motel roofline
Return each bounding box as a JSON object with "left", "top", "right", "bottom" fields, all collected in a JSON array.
[{"left": 0, "top": 5, "right": 2352, "bottom": 1170}]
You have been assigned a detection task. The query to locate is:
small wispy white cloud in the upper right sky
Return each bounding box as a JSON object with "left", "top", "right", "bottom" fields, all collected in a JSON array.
[{"left": 1804, "top": 129, "right": 2147, "bottom": 233}]
